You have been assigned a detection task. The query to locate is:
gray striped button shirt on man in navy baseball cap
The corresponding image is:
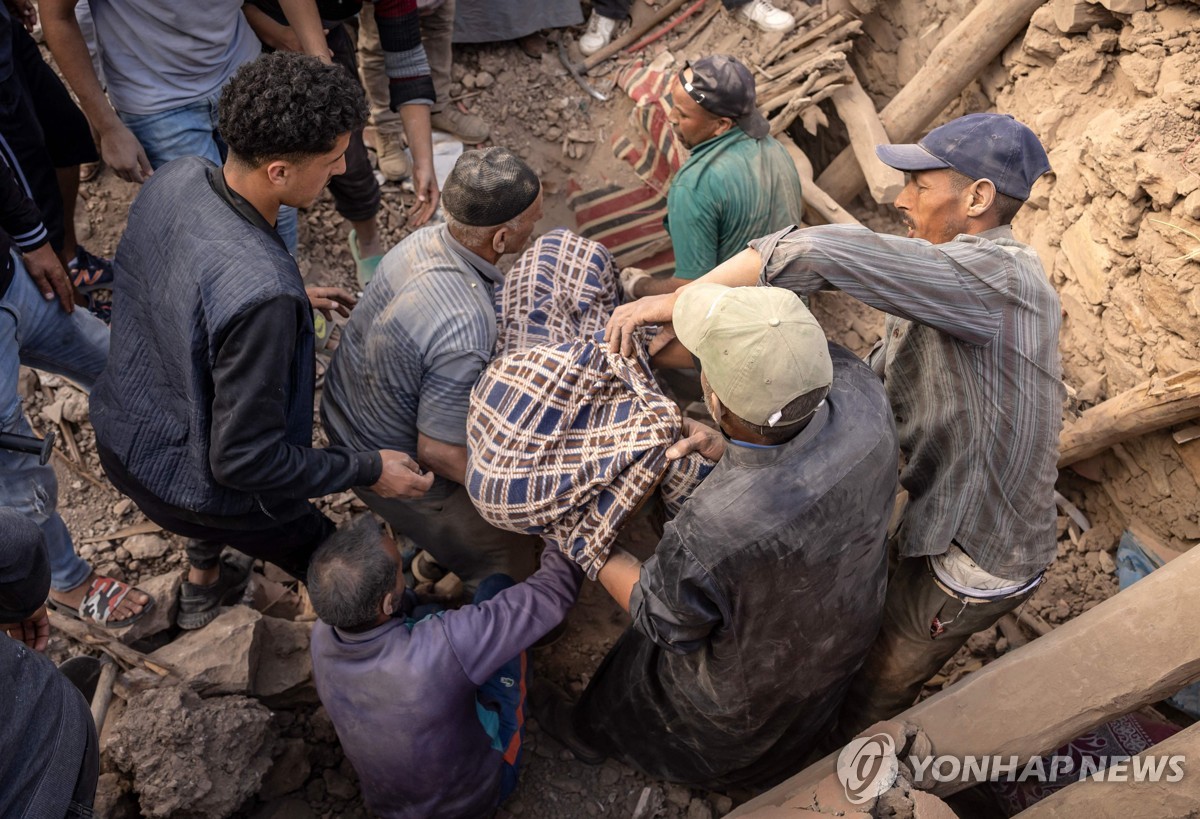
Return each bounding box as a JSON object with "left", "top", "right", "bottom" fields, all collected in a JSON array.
[{"left": 751, "top": 225, "right": 1066, "bottom": 580}]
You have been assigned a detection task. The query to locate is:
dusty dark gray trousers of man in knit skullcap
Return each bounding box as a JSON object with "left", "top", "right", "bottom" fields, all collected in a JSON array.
[{"left": 354, "top": 477, "right": 542, "bottom": 586}]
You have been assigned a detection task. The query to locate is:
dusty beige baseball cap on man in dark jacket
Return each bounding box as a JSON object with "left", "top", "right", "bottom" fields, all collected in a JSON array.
[{"left": 672, "top": 283, "right": 833, "bottom": 426}]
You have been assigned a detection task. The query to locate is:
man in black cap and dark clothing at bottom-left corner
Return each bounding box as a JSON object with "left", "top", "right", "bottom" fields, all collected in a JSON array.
[{"left": 0, "top": 507, "right": 100, "bottom": 817}]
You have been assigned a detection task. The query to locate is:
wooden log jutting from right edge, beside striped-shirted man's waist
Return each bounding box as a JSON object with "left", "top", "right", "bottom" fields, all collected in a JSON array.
[{"left": 1058, "top": 369, "right": 1200, "bottom": 470}]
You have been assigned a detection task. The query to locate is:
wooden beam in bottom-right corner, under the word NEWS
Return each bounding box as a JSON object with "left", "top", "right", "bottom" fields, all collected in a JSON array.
[{"left": 1016, "top": 723, "right": 1200, "bottom": 819}]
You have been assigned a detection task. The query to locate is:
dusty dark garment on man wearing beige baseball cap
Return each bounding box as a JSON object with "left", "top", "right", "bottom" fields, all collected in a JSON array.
[{"left": 577, "top": 345, "right": 898, "bottom": 788}]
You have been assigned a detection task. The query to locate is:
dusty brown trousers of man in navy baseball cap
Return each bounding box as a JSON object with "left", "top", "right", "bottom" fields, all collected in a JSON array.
[{"left": 835, "top": 557, "right": 1036, "bottom": 743}]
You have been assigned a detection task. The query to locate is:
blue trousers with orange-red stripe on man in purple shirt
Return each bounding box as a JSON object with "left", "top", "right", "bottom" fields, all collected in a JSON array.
[{"left": 472, "top": 574, "right": 529, "bottom": 802}]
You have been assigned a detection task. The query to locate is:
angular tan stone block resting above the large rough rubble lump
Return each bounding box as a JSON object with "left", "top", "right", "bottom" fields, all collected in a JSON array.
[{"left": 150, "top": 605, "right": 263, "bottom": 697}]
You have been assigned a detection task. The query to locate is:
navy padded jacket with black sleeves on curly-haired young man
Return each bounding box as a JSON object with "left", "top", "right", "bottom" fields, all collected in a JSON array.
[{"left": 91, "top": 157, "right": 380, "bottom": 518}]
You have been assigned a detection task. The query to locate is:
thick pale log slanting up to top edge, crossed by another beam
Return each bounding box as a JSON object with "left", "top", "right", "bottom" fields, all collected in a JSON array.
[{"left": 817, "top": 0, "right": 1044, "bottom": 204}]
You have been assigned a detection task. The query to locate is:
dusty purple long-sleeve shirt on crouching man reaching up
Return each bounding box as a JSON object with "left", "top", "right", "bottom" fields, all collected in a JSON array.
[{"left": 312, "top": 549, "right": 583, "bottom": 818}]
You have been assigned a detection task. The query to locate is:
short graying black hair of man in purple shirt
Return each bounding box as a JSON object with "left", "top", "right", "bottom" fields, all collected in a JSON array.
[{"left": 307, "top": 514, "right": 397, "bottom": 628}]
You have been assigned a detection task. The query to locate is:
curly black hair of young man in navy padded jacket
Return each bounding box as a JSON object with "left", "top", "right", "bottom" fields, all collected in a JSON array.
[{"left": 217, "top": 52, "right": 368, "bottom": 168}]
